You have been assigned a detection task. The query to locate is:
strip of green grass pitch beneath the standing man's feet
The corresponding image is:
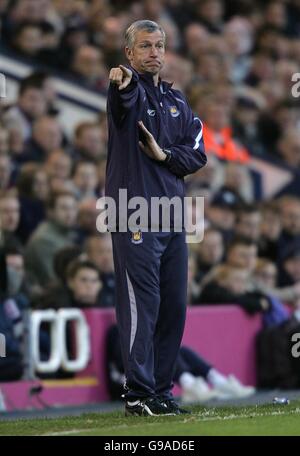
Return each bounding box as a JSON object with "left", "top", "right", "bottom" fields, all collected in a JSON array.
[{"left": 0, "top": 401, "right": 300, "bottom": 436}]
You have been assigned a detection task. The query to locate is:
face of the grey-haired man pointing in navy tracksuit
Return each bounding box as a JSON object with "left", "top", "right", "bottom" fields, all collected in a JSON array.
[{"left": 125, "top": 30, "right": 165, "bottom": 75}]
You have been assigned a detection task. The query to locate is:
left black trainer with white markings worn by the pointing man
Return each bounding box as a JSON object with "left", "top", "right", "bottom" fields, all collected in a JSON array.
[{"left": 125, "top": 397, "right": 176, "bottom": 416}]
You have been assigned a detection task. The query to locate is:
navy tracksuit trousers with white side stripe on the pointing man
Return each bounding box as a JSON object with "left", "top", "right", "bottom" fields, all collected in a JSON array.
[{"left": 112, "top": 231, "right": 187, "bottom": 400}]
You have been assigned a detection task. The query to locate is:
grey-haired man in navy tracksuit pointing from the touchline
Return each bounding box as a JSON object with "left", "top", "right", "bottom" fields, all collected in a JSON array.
[{"left": 106, "top": 21, "right": 206, "bottom": 415}]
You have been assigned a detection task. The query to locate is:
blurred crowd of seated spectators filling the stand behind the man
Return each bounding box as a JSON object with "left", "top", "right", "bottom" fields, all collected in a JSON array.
[{"left": 0, "top": 0, "right": 300, "bottom": 379}]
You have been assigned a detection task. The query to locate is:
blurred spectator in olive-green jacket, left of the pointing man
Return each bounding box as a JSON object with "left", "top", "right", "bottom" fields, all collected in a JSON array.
[{"left": 25, "top": 192, "right": 77, "bottom": 291}]
